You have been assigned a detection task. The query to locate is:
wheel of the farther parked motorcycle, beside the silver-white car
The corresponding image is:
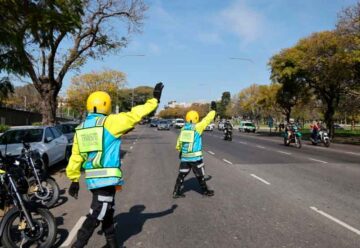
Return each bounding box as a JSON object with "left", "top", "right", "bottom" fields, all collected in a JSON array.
[{"left": 26, "top": 177, "right": 60, "bottom": 208}]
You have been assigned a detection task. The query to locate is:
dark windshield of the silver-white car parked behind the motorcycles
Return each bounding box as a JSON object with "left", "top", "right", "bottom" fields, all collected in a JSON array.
[{"left": 1, "top": 128, "right": 44, "bottom": 144}]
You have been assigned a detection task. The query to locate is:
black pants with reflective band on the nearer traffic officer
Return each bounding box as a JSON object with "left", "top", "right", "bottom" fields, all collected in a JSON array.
[{"left": 72, "top": 186, "right": 115, "bottom": 248}]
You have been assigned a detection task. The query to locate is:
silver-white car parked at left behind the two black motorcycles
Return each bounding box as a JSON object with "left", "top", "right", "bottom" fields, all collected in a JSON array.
[{"left": 0, "top": 126, "right": 71, "bottom": 167}]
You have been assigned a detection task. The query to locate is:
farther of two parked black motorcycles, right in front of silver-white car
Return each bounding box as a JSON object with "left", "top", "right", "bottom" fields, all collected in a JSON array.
[{"left": 19, "top": 143, "right": 60, "bottom": 208}]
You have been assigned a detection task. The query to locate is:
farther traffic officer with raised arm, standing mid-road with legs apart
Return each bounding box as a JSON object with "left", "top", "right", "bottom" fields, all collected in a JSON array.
[{"left": 173, "top": 102, "right": 216, "bottom": 198}]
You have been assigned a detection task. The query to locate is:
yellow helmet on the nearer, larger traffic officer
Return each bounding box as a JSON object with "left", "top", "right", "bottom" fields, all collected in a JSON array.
[{"left": 86, "top": 91, "right": 111, "bottom": 115}]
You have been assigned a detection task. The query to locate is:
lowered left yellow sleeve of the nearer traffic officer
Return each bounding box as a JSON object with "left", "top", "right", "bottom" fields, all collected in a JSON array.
[{"left": 66, "top": 135, "right": 84, "bottom": 182}]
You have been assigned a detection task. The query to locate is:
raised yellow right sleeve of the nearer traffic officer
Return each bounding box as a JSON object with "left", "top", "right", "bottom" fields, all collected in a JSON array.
[{"left": 104, "top": 98, "right": 158, "bottom": 138}]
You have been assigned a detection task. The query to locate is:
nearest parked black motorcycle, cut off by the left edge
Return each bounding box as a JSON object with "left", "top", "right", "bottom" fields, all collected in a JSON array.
[{"left": 0, "top": 153, "right": 57, "bottom": 248}]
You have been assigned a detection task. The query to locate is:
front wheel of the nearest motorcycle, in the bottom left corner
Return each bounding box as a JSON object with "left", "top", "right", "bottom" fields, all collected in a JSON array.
[{"left": 1, "top": 208, "right": 57, "bottom": 248}]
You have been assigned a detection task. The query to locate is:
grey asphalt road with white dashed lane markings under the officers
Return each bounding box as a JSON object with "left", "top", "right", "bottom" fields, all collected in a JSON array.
[{"left": 45, "top": 126, "right": 360, "bottom": 248}]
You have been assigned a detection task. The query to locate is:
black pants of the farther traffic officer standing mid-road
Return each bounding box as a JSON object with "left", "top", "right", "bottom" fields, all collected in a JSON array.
[{"left": 174, "top": 160, "right": 208, "bottom": 193}]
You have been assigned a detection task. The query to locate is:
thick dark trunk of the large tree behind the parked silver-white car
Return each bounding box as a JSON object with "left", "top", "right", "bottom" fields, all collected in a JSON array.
[{"left": 36, "top": 79, "right": 59, "bottom": 125}]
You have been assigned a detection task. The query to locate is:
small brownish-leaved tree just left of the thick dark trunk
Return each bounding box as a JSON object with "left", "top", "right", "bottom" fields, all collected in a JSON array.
[{"left": 6, "top": 84, "right": 41, "bottom": 112}]
